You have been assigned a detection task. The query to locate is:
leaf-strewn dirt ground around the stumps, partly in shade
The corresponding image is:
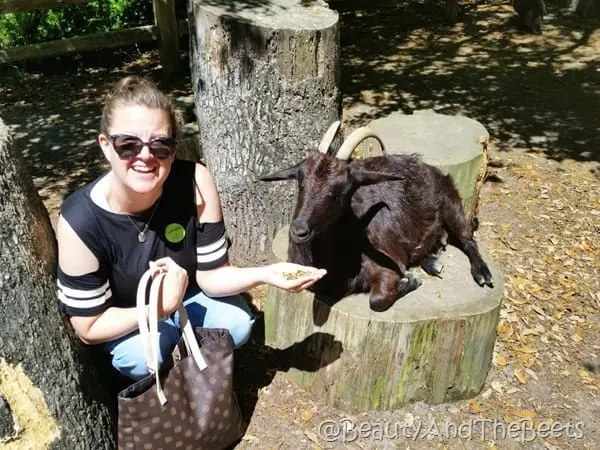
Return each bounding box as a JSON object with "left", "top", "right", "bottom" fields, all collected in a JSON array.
[{"left": 0, "top": 1, "right": 600, "bottom": 449}]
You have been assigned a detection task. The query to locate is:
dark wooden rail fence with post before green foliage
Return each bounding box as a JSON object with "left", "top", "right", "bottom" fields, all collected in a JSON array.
[{"left": 0, "top": 0, "right": 183, "bottom": 75}]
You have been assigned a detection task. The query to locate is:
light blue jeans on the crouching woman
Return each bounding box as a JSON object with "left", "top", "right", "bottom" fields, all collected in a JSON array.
[{"left": 104, "top": 292, "right": 255, "bottom": 380}]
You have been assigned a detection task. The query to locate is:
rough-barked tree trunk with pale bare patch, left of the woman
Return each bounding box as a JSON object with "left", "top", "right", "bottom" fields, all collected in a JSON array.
[{"left": 0, "top": 119, "right": 114, "bottom": 450}]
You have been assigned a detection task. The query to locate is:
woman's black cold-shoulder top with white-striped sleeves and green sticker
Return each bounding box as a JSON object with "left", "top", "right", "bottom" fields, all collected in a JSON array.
[{"left": 57, "top": 160, "right": 228, "bottom": 316}]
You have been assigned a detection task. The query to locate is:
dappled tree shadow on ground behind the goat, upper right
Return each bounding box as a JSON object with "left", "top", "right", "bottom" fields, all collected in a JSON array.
[{"left": 338, "top": 0, "right": 600, "bottom": 162}]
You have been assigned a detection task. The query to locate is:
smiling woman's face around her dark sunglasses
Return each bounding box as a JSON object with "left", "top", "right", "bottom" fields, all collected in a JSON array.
[{"left": 98, "top": 105, "right": 175, "bottom": 194}]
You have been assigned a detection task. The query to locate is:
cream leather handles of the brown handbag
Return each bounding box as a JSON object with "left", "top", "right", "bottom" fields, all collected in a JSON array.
[{"left": 136, "top": 268, "right": 207, "bottom": 405}]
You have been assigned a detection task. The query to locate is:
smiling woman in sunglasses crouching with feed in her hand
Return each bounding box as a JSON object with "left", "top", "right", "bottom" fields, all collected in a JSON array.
[{"left": 57, "top": 77, "right": 324, "bottom": 380}]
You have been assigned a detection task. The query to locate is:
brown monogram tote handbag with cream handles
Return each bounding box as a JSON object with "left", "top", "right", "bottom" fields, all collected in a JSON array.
[{"left": 118, "top": 270, "right": 245, "bottom": 450}]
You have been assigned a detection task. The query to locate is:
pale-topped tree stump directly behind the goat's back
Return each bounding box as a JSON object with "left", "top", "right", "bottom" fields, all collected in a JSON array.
[{"left": 368, "top": 110, "right": 489, "bottom": 218}]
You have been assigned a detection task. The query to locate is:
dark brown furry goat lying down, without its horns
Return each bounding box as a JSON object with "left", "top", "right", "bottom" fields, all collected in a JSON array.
[{"left": 261, "top": 153, "right": 492, "bottom": 311}]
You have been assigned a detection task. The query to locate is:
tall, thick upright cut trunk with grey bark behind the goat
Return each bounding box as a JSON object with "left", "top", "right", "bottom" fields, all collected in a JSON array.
[{"left": 189, "top": 0, "right": 341, "bottom": 263}]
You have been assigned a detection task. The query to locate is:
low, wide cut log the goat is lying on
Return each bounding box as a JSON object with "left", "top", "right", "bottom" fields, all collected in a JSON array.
[{"left": 264, "top": 228, "right": 503, "bottom": 411}]
